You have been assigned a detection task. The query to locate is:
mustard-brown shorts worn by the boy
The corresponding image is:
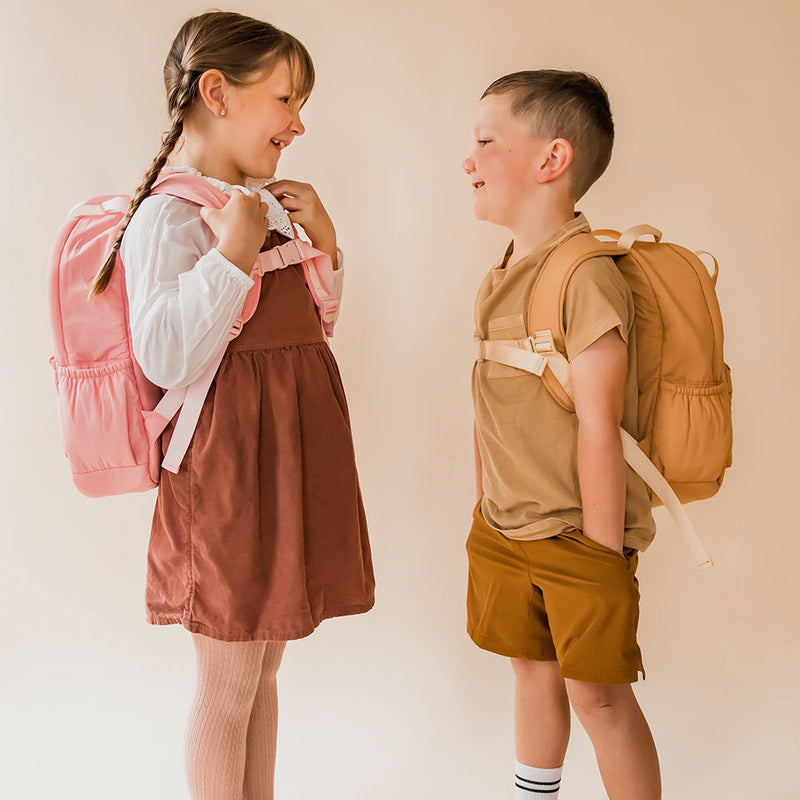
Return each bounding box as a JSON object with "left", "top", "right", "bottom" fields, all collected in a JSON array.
[{"left": 467, "top": 503, "right": 644, "bottom": 683}]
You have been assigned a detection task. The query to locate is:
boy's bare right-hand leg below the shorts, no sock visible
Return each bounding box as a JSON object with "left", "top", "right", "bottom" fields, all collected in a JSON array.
[{"left": 566, "top": 678, "right": 661, "bottom": 800}]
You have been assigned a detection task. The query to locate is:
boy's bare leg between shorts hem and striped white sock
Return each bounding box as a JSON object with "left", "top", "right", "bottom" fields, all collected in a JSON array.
[{"left": 511, "top": 658, "right": 570, "bottom": 769}]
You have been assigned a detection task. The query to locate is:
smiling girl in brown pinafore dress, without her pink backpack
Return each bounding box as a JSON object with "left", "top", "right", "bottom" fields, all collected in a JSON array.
[{"left": 95, "top": 12, "right": 374, "bottom": 800}]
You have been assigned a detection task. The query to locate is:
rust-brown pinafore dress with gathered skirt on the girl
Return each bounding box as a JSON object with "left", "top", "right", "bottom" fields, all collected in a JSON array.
[{"left": 145, "top": 234, "right": 375, "bottom": 641}]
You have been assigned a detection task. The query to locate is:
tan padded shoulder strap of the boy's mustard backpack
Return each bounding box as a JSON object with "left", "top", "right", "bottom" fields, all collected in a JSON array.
[{"left": 527, "top": 233, "right": 625, "bottom": 412}]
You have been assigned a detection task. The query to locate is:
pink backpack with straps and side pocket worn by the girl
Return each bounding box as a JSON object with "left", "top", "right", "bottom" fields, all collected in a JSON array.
[{"left": 48, "top": 172, "right": 338, "bottom": 497}]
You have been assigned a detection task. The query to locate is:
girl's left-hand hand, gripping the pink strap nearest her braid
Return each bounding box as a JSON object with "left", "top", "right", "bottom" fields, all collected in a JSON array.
[{"left": 200, "top": 189, "right": 269, "bottom": 275}]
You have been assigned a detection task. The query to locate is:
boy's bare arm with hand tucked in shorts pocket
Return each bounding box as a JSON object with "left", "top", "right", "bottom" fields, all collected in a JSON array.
[{"left": 570, "top": 328, "right": 628, "bottom": 554}]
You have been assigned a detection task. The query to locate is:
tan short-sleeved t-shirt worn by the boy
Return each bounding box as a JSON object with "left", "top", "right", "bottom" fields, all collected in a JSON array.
[{"left": 472, "top": 214, "right": 655, "bottom": 550}]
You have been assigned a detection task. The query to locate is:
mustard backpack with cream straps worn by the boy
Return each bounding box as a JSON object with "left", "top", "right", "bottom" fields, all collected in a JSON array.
[{"left": 476, "top": 225, "right": 733, "bottom": 567}]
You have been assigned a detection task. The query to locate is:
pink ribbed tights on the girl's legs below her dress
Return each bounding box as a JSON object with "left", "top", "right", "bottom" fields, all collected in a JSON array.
[{"left": 186, "top": 633, "right": 286, "bottom": 800}]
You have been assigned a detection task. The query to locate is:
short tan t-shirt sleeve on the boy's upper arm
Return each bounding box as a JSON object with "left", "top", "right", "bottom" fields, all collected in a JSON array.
[{"left": 564, "top": 257, "right": 634, "bottom": 361}]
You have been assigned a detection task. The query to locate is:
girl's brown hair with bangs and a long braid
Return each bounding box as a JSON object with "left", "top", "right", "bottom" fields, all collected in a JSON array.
[{"left": 90, "top": 11, "right": 314, "bottom": 297}]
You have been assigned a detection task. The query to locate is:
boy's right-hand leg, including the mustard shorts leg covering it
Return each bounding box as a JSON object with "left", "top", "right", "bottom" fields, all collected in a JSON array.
[{"left": 526, "top": 531, "right": 661, "bottom": 800}]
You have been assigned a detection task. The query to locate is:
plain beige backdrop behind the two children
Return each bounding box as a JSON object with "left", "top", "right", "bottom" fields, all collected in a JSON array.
[{"left": 0, "top": 0, "right": 800, "bottom": 800}]
